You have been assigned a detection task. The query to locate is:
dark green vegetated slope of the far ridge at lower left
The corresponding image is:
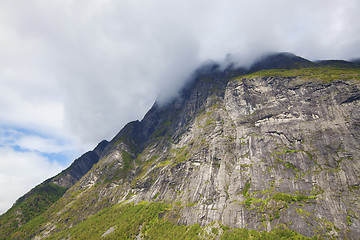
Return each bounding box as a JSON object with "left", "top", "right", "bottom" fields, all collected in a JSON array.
[{"left": 0, "top": 183, "right": 67, "bottom": 238}]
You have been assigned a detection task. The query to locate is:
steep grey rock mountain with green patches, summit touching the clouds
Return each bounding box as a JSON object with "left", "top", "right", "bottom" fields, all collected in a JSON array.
[{"left": 0, "top": 53, "right": 360, "bottom": 239}]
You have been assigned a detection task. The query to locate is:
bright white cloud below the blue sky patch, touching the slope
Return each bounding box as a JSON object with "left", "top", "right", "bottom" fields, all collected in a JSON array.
[{"left": 0, "top": 147, "right": 64, "bottom": 214}]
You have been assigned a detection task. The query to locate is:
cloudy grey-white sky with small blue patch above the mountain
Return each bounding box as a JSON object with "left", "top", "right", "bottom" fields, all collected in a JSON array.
[{"left": 0, "top": 0, "right": 360, "bottom": 213}]
